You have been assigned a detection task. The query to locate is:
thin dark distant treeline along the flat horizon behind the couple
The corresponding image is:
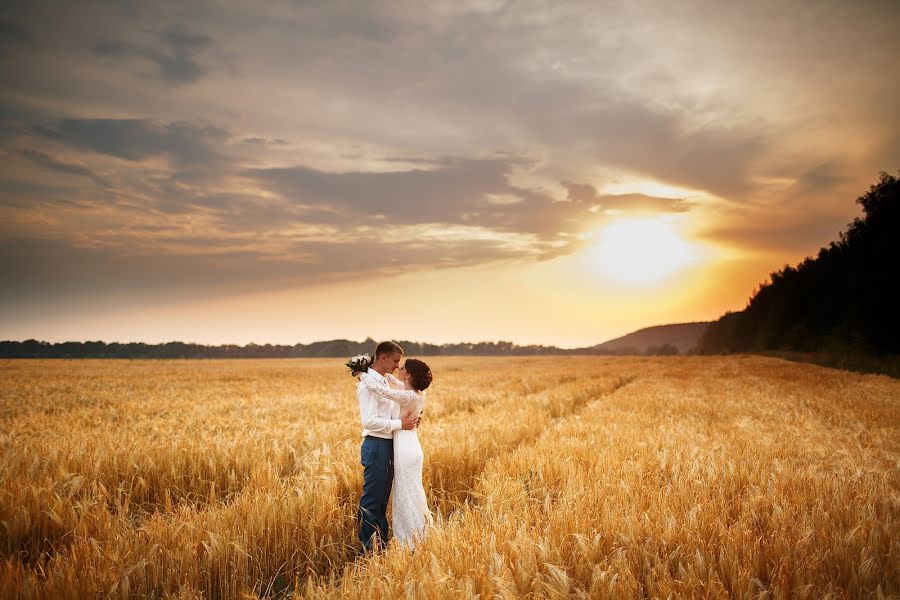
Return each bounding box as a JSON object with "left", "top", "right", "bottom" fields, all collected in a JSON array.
[{"left": 0, "top": 339, "right": 678, "bottom": 358}]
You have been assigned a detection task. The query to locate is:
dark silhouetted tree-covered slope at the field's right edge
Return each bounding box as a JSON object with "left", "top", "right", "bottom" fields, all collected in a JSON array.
[{"left": 696, "top": 173, "right": 900, "bottom": 358}]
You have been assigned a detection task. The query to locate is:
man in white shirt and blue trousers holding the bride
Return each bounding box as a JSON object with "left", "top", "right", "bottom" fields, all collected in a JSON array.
[{"left": 356, "top": 342, "right": 418, "bottom": 554}]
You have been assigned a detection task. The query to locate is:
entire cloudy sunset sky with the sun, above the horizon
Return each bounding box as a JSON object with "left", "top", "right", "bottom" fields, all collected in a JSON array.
[{"left": 0, "top": 0, "right": 900, "bottom": 348}]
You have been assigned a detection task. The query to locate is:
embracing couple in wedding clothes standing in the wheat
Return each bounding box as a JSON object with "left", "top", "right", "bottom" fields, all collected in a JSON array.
[{"left": 348, "top": 342, "right": 432, "bottom": 554}]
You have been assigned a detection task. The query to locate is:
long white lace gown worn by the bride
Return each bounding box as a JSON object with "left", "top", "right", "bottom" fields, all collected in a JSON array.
[{"left": 364, "top": 375, "right": 432, "bottom": 549}]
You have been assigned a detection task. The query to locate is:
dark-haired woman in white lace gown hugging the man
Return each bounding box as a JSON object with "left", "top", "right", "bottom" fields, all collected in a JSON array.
[{"left": 360, "top": 358, "right": 432, "bottom": 549}]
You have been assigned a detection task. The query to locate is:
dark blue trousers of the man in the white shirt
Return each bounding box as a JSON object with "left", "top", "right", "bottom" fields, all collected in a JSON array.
[{"left": 356, "top": 436, "right": 394, "bottom": 553}]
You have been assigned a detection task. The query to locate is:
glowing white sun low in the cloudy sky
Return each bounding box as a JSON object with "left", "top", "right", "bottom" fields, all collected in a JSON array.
[{"left": 592, "top": 218, "right": 697, "bottom": 285}]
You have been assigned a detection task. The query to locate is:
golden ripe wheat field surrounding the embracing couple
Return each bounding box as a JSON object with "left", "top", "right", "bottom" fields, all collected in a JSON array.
[{"left": 0, "top": 356, "right": 900, "bottom": 598}]
